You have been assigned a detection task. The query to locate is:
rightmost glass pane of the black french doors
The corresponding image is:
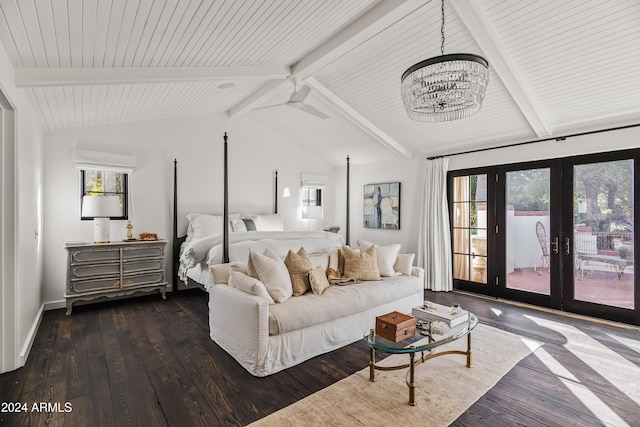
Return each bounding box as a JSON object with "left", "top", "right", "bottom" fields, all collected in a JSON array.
[{"left": 573, "top": 160, "right": 634, "bottom": 309}]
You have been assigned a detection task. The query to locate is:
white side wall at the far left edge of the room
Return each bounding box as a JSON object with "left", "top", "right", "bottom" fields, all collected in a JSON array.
[{"left": 0, "top": 41, "right": 43, "bottom": 372}]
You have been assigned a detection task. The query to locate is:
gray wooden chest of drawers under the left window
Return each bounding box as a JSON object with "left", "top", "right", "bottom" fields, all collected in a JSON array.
[{"left": 64, "top": 240, "right": 169, "bottom": 315}]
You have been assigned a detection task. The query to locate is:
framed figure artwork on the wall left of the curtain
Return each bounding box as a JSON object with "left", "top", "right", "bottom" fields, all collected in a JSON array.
[{"left": 362, "top": 182, "right": 400, "bottom": 230}]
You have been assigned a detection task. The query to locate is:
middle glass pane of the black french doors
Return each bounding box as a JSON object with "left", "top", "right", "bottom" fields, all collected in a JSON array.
[{"left": 505, "top": 168, "right": 551, "bottom": 295}]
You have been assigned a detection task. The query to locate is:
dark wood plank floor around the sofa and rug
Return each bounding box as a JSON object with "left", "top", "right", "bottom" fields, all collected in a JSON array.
[{"left": 0, "top": 291, "right": 640, "bottom": 426}]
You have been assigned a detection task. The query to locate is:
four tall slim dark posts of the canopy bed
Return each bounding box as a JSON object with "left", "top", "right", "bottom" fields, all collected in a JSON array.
[{"left": 173, "top": 132, "right": 350, "bottom": 292}]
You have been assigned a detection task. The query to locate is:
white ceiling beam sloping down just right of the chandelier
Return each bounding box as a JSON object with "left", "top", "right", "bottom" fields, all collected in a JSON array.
[{"left": 450, "top": 0, "right": 551, "bottom": 138}]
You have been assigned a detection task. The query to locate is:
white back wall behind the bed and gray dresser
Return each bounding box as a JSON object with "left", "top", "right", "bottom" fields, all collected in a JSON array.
[{"left": 44, "top": 114, "right": 335, "bottom": 307}]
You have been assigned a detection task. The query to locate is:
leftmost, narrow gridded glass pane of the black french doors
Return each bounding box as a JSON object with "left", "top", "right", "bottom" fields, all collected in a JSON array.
[{"left": 453, "top": 175, "right": 487, "bottom": 284}]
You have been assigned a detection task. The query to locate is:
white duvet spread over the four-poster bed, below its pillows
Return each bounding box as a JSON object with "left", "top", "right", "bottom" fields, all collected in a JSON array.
[{"left": 179, "top": 231, "right": 343, "bottom": 284}]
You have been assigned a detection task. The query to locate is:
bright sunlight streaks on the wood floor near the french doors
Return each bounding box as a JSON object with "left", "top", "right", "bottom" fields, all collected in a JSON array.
[{"left": 525, "top": 315, "right": 640, "bottom": 426}]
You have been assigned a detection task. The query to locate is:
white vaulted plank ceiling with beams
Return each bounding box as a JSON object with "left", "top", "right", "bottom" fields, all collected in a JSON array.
[{"left": 0, "top": 0, "right": 640, "bottom": 164}]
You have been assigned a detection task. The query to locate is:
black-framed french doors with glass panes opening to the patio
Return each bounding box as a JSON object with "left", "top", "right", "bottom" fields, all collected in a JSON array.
[{"left": 449, "top": 150, "right": 640, "bottom": 324}]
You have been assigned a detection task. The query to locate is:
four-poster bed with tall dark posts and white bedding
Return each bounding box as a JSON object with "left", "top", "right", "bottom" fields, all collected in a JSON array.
[{"left": 173, "top": 132, "right": 349, "bottom": 291}]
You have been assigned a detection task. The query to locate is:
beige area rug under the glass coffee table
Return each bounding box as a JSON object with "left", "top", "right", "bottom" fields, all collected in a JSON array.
[{"left": 251, "top": 325, "right": 540, "bottom": 427}]
